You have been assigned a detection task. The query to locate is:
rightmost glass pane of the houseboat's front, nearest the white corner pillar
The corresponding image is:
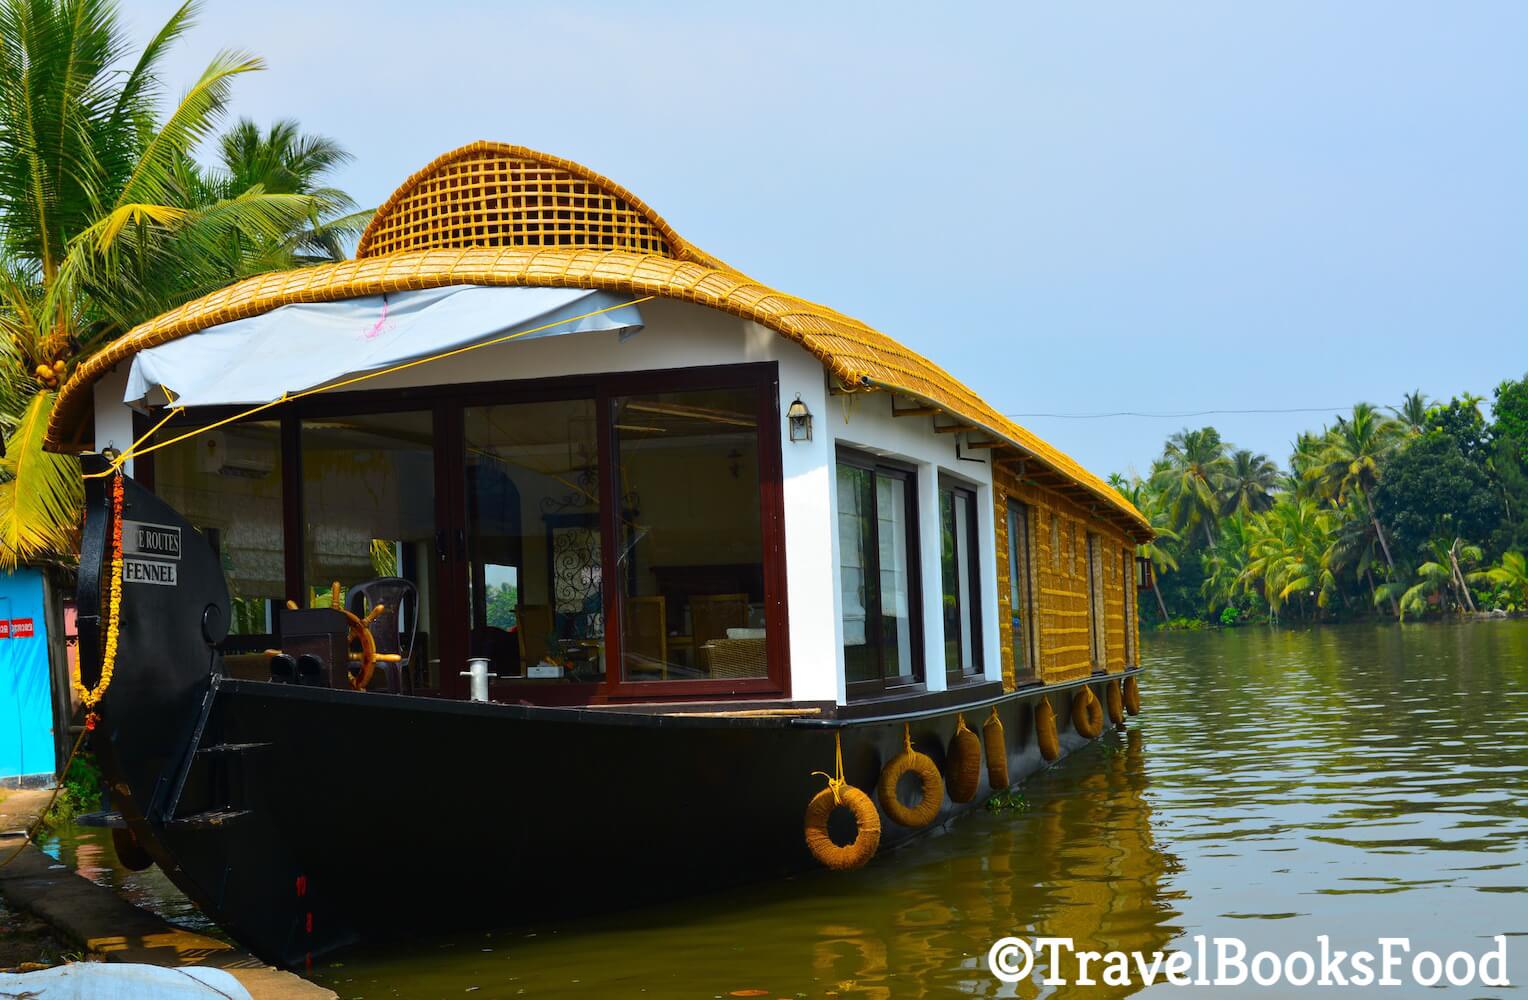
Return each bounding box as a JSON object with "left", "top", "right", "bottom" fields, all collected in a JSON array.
[{"left": 611, "top": 387, "right": 772, "bottom": 682}]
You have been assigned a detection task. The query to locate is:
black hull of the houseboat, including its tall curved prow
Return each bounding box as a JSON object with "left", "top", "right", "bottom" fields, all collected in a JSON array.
[{"left": 79, "top": 464, "right": 1142, "bottom": 966}]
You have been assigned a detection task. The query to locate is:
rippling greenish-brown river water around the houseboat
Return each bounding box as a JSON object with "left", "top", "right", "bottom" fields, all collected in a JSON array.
[{"left": 41, "top": 621, "right": 1528, "bottom": 1000}]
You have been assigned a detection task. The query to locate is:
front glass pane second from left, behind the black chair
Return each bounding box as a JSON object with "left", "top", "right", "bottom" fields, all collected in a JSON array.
[{"left": 301, "top": 413, "right": 440, "bottom": 690}]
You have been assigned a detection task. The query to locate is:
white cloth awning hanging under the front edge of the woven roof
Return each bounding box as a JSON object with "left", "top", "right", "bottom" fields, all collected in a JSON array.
[{"left": 125, "top": 284, "right": 642, "bottom": 408}]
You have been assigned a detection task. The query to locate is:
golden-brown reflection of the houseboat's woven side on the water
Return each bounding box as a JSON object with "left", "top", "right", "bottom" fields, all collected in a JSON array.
[{"left": 813, "top": 729, "right": 1181, "bottom": 1000}]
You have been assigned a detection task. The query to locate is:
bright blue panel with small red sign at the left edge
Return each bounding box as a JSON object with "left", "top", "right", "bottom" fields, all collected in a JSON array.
[{"left": 0, "top": 569, "right": 53, "bottom": 778}]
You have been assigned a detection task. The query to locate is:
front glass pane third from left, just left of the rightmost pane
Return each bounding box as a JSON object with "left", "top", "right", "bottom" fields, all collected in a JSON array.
[{"left": 463, "top": 399, "right": 605, "bottom": 682}]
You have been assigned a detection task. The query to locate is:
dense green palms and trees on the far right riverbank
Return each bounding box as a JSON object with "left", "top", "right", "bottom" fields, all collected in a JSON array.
[{"left": 1109, "top": 382, "right": 1528, "bottom": 627}]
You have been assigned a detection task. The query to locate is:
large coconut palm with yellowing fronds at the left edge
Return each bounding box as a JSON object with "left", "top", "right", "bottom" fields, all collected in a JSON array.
[{"left": 0, "top": 0, "right": 348, "bottom": 567}]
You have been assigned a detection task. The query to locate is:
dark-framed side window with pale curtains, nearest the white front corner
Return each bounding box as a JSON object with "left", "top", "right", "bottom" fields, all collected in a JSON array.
[{"left": 837, "top": 456, "right": 918, "bottom": 693}]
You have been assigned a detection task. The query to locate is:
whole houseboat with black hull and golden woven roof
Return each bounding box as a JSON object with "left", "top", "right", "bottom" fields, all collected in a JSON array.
[{"left": 49, "top": 142, "right": 1151, "bottom": 965}]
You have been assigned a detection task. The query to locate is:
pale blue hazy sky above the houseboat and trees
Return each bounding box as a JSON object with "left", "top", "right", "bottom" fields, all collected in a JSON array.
[{"left": 124, "top": 0, "right": 1528, "bottom": 474}]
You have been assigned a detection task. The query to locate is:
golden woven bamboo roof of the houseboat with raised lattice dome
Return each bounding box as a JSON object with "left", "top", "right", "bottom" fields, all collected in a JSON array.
[{"left": 47, "top": 142, "right": 1151, "bottom": 540}]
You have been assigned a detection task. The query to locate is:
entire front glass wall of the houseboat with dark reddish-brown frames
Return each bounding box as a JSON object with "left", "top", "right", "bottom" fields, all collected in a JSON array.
[{"left": 145, "top": 364, "right": 788, "bottom": 703}]
